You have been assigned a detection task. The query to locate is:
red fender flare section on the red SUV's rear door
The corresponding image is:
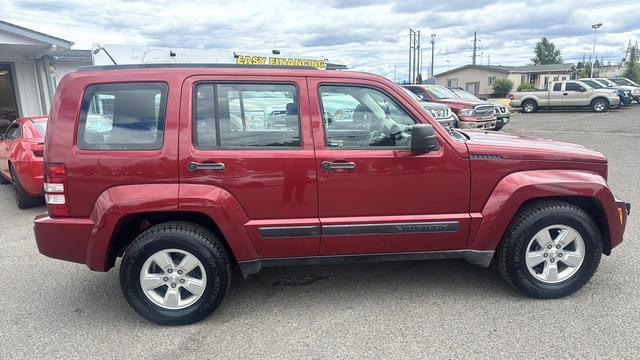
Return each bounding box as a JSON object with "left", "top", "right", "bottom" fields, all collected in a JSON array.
[{"left": 179, "top": 183, "right": 258, "bottom": 261}]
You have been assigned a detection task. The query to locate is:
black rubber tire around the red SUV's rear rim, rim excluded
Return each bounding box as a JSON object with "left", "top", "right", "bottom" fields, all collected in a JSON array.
[{"left": 120, "top": 222, "right": 231, "bottom": 325}]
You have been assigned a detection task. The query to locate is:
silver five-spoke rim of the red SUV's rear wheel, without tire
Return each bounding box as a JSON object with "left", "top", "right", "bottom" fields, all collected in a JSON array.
[{"left": 140, "top": 249, "right": 207, "bottom": 310}]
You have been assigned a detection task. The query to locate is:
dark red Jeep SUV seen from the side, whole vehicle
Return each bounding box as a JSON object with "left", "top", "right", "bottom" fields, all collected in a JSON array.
[{"left": 34, "top": 64, "right": 630, "bottom": 325}]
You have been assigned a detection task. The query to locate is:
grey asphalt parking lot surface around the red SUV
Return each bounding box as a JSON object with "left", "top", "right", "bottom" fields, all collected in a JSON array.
[{"left": 0, "top": 104, "right": 640, "bottom": 359}]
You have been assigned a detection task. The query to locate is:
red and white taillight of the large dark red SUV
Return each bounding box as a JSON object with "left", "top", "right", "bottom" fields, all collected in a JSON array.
[{"left": 44, "top": 163, "right": 69, "bottom": 216}]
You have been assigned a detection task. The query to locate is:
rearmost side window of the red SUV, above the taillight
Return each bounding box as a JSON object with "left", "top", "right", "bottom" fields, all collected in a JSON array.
[{"left": 78, "top": 83, "right": 167, "bottom": 150}]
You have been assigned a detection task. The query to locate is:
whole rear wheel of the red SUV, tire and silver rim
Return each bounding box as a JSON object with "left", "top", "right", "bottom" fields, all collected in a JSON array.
[{"left": 120, "top": 222, "right": 231, "bottom": 325}]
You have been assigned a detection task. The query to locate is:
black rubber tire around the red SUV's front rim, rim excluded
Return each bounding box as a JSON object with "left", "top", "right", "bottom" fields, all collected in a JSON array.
[{"left": 498, "top": 201, "right": 602, "bottom": 299}]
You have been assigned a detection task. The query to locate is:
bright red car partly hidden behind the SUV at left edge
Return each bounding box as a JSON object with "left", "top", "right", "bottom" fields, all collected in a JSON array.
[{"left": 0, "top": 116, "right": 47, "bottom": 209}]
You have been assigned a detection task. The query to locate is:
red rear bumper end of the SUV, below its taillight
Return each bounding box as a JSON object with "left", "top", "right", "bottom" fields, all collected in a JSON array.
[{"left": 33, "top": 214, "right": 94, "bottom": 264}]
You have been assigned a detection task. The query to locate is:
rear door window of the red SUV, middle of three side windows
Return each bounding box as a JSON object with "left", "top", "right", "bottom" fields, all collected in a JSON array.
[{"left": 193, "top": 83, "right": 300, "bottom": 149}]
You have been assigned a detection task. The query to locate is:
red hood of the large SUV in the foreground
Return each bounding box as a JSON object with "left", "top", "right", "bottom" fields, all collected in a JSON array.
[{"left": 463, "top": 130, "right": 607, "bottom": 163}]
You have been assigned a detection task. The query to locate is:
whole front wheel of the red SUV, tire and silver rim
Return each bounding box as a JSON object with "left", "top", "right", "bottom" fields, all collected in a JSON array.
[{"left": 498, "top": 201, "right": 602, "bottom": 299}]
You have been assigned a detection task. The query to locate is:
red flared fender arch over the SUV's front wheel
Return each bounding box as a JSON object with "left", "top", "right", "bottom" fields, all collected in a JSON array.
[{"left": 468, "top": 170, "right": 624, "bottom": 250}]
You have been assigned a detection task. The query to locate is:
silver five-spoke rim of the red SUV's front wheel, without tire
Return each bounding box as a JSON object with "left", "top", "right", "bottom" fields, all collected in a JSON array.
[{"left": 525, "top": 224, "right": 585, "bottom": 284}]
